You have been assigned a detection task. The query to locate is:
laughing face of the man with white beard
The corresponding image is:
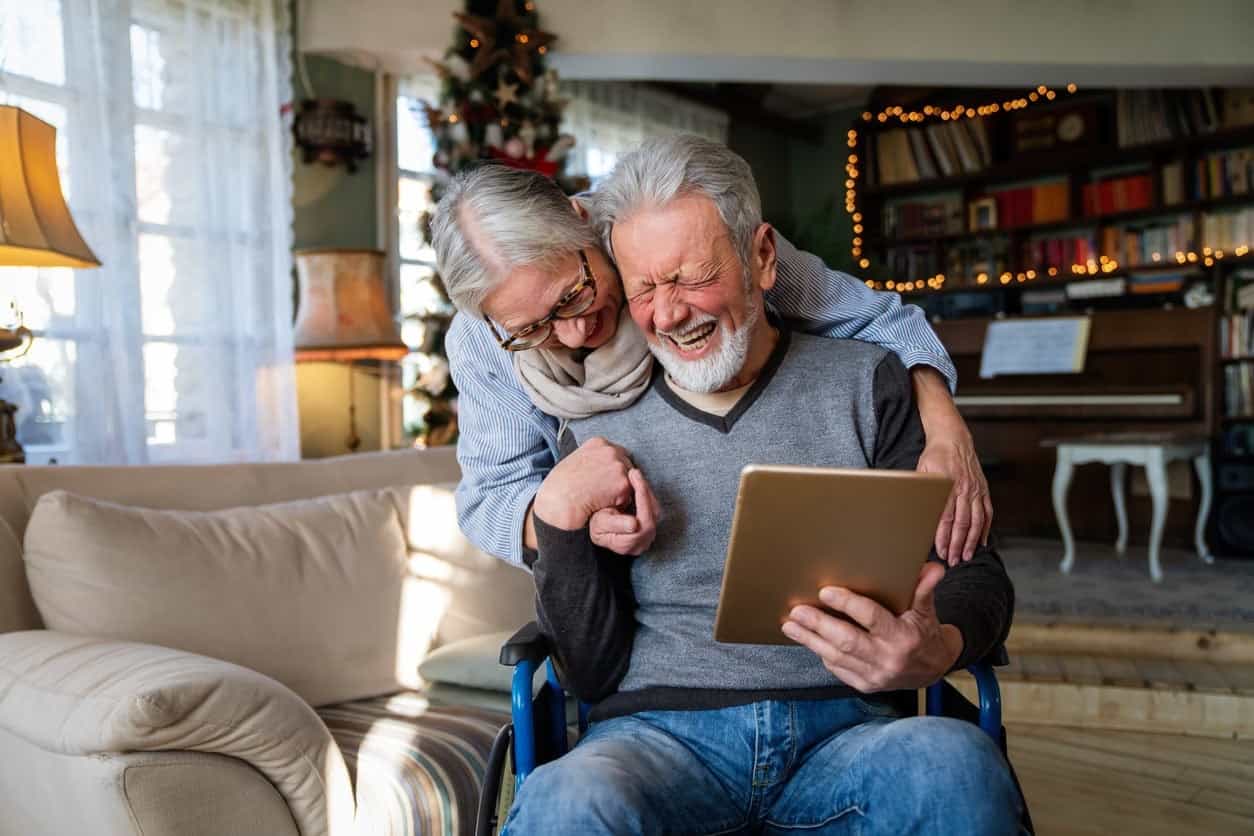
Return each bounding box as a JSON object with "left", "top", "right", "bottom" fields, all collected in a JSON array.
[{"left": 613, "top": 196, "right": 775, "bottom": 392}]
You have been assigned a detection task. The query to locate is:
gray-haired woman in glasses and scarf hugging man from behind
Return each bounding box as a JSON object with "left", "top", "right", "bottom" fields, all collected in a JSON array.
[{"left": 433, "top": 154, "right": 992, "bottom": 571}]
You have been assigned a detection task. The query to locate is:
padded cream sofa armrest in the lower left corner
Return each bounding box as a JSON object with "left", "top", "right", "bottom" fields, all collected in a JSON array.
[{"left": 0, "top": 630, "right": 354, "bottom": 836}]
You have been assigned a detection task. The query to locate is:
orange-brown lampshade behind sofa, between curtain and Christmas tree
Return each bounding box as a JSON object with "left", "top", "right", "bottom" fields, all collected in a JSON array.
[{"left": 296, "top": 249, "right": 409, "bottom": 361}]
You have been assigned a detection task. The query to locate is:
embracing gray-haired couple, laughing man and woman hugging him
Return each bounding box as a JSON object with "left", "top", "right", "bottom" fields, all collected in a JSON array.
[{"left": 433, "top": 135, "right": 1021, "bottom": 835}]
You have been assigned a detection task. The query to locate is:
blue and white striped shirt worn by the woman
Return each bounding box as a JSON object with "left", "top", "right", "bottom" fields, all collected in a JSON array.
[{"left": 445, "top": 232, "right": 957, "bottom": 564}]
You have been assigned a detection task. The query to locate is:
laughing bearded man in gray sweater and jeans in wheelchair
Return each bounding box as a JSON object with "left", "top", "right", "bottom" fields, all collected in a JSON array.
[{"left": 486, "top": 137, "right": 1021, "bottom": 835}]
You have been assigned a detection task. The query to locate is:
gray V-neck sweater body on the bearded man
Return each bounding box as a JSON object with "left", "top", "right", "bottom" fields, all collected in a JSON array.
[{"left": 562, "top": 332, "right": 923, "bottom": 693}]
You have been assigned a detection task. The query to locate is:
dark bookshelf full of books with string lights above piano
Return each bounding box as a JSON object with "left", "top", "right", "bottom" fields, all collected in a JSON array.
[{"left": 854, "top": 90, "right": 1254, "bottom": 310}]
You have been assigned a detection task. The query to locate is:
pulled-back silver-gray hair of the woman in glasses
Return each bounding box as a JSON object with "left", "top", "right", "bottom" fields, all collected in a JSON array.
[{"left": 431, "top": 164, "right": 597, "bottom": 316}]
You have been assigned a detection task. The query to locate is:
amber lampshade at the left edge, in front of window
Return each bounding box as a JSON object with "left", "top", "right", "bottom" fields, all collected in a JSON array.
[{"left": 0, "top": 105, "right": 100, "bottom": 267}]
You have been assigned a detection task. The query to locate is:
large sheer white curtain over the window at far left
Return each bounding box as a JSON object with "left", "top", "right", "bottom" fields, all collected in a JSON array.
[{"left": 0, "top": 0, "right": 300, "bottom": 464}]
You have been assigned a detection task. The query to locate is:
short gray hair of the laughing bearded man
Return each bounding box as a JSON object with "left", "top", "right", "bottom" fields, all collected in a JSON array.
[{"left": 592, "top": 134, "right": 762, "bottom": 272}]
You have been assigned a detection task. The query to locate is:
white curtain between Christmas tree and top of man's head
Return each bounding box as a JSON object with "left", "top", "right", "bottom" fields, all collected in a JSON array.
[{"left": 562, "top": 81, "right": 727, "bottom": 184}]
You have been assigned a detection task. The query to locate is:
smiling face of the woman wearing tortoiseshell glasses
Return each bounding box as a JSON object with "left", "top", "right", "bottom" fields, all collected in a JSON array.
[{"left": 483, "top": 247, "right": 623, "bottom": 348}]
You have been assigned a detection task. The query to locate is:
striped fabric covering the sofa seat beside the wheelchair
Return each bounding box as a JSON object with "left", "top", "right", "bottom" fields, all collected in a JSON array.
[{"left": 319, "top": 692, "right": 509, "bottom": 836}]
